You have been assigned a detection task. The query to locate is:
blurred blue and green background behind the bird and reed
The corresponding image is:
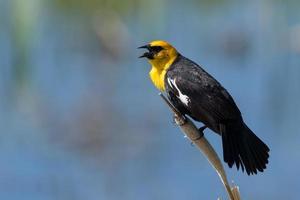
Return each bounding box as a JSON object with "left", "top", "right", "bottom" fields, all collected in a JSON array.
[{"left": 0, "top": 0, "right": 300, "bottom": 200}]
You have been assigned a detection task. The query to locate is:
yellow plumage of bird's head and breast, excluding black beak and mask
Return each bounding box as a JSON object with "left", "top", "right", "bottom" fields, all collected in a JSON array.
[{"left": 148, "top": 40, "right": 178, "bottom": 91}]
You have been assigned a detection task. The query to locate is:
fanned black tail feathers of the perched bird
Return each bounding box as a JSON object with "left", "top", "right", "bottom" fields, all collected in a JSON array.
[{"left": 220, "top": 122, "right": 270, "bottom": 175}]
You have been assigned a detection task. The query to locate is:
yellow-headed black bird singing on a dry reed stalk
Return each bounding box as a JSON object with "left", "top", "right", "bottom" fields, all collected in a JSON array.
[{"left": 138, "top": 40, "right": 270, "bottom": 175}]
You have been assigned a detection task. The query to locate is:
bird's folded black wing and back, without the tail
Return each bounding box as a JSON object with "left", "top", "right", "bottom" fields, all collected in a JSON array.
[{"left": 165, "top": 57, "right": 241, "bottom": 133}]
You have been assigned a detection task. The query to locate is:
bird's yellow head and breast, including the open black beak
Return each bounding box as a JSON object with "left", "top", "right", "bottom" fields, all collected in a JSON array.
[{"left": 139, "top": 40, "right": 179, "bottom": 91}]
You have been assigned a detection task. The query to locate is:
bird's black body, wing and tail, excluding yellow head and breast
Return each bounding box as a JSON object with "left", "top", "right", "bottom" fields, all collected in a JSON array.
[{"left": 164, "top": 55, "right": 269, "bottom": 175}]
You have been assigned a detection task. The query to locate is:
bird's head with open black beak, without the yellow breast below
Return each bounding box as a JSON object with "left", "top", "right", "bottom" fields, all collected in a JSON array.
[{"left": 139, "top": 40, "right": 178, "bottom": 70}]
